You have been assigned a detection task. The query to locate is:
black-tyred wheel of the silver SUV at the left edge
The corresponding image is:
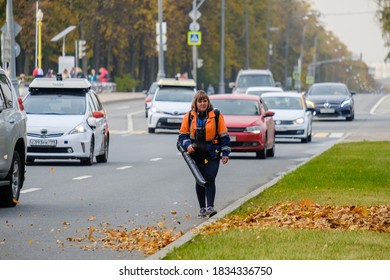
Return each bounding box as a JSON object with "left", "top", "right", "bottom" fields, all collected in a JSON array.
[{"left": 0, "top": 151, "right": 23, "bottom": 207}]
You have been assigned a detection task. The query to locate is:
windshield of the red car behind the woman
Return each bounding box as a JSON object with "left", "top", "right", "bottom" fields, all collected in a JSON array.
[{"left": 211, "top": 99, "right": 260, "bottom": 116}]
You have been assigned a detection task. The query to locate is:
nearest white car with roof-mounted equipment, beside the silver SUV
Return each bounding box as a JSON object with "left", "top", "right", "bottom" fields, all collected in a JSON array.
[{"left": 23, "top": 75, "right": 110, "bottom": 165}]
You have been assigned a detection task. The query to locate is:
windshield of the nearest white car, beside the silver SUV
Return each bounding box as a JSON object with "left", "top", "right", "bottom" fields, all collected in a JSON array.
[{"left": 23, "top": 93, "right": 86, "bottom": 115}]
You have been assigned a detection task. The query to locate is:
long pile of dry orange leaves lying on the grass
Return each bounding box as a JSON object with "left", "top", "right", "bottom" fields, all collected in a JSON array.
[{"left": 200, "top": 200, "right": 390, "bottom": 234}]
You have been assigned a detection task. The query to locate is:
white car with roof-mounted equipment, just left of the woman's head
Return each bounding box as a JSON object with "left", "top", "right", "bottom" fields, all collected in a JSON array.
[{"left": 148, "top": 79, "right": 196, "bottom": 133}]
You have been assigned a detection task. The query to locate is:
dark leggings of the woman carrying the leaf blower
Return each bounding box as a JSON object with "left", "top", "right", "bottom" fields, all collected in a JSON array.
[{"left": 196, "top": 156, "right": 220, "bottom": 208}]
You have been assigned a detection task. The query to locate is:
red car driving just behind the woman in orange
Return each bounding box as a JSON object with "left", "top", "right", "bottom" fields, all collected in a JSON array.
[{"left": 210, "top": 94, "right": 275, "bottom": 159}]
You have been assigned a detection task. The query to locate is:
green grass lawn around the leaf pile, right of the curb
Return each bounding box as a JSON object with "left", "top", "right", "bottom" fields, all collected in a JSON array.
[{"left": 165, "top": 142, "right": 390, "bottom": 260}]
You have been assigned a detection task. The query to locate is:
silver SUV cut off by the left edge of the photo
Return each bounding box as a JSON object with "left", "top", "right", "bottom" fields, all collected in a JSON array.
[{"left": 0, "top": 68, "right": 27, "bottom": 207}]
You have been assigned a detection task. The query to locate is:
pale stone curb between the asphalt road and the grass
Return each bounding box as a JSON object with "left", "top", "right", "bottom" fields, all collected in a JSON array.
[{"left": 146, "top": 133, "right": 350, "bottom": 260}]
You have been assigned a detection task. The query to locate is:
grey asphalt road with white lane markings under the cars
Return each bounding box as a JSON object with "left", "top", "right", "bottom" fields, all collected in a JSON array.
[{"left": 0, "top": 92, "right": 390, "bottom": 260}]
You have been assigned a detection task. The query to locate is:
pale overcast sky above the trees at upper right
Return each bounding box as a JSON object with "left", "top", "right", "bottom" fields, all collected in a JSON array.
[{"left": 309, "top": 0, "right": 390, "bottom": 76}]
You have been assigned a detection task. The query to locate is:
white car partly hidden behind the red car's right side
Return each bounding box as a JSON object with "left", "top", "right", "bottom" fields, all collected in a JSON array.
[{"left": 261, "top": 92, "right": 313, "bottom": 143}]
